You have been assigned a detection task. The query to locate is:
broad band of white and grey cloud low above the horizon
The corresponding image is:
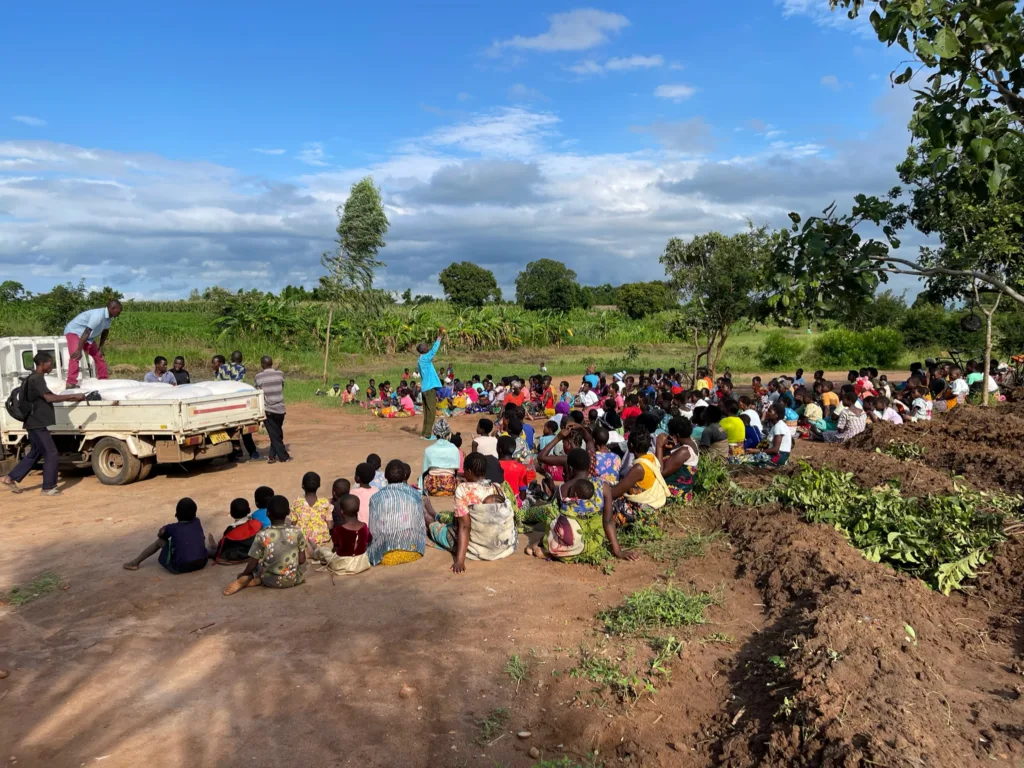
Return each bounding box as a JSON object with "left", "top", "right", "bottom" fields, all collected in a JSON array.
[{"left": 0, "top": 89, "right": 925, "bottom": 298}]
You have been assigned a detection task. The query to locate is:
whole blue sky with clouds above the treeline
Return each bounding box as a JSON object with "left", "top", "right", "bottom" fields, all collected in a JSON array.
[{"left": 0, "top": 0, "right": 929, "bottom": 299}]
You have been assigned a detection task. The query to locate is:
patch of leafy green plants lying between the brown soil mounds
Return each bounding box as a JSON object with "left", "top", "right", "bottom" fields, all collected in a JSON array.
[{"left": 734, "top": 462, "right": 1024, "bottom": 595}]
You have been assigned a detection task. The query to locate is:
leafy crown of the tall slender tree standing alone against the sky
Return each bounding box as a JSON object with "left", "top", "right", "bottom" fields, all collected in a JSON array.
[{"left": 321, "top": 176, "right": 390, "bottom": 296}]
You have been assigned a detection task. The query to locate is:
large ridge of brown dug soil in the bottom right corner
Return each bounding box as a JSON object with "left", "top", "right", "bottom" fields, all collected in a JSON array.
[{"left": 717, "top": 509, "right": 1024, "bottom": 767}]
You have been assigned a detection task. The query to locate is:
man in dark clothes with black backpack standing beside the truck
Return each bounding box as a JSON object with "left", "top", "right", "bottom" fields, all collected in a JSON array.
[{"left": 0, "top": 352, "right": 85, "bottom": 496}]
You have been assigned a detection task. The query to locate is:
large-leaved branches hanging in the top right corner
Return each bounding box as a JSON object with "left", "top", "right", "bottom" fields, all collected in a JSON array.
[{"left": 829, "top": 0, "right": 1024, "bottom": 194}]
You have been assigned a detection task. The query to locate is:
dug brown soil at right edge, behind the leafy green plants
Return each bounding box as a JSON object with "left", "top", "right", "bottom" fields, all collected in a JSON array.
[{"left": 850, "top": 402, "right": 1024, "bottom": 493}]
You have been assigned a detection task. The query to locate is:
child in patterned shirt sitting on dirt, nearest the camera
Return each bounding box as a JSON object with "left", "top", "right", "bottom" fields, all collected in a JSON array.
[{"left": 224, "top": 496, "right": 306, "bottom": 595}]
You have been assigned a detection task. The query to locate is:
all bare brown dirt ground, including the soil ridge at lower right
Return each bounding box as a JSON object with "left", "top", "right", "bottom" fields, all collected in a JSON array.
[{"left": 0, "top": 391, "right": 1024, "bottom": 768}]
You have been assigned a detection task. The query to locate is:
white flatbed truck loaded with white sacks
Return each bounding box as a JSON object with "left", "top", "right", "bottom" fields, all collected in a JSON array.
[{"left": 0, "top": 336, "right": 264, "bottom": 485}]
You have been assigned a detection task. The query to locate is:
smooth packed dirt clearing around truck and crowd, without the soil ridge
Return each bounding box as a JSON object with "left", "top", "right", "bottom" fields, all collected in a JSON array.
[{"left": 0, "top": 407, "right": 770, "bottom": 768}]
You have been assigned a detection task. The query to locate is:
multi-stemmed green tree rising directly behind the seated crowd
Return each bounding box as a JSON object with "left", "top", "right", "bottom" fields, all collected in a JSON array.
[{"left": 660, "top": 226, "right": 773, "bottom": 374}]
